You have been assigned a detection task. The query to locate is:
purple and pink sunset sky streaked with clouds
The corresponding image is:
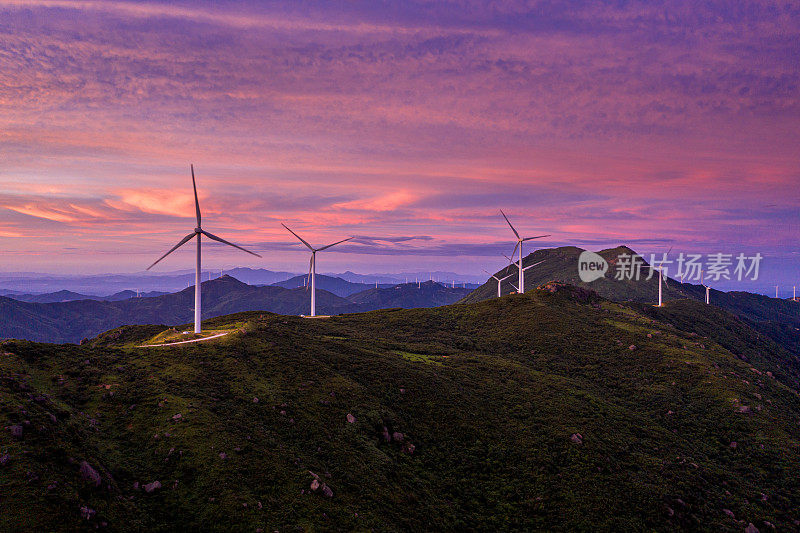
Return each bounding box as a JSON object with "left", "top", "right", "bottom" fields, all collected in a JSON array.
[{"left": 0, "top": 0, "right": 800, "bottom": 282}]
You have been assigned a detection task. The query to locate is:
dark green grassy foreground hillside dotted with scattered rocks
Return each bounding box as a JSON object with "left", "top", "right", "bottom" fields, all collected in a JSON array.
[{"left": 0, "top": 284, "right": 800, "bottom": 531}]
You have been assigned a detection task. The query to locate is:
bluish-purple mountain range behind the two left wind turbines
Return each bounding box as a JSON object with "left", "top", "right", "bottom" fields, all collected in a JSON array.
[{"left": 0, "top": 275, "right": 469, "bottom": 343}]
